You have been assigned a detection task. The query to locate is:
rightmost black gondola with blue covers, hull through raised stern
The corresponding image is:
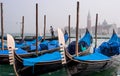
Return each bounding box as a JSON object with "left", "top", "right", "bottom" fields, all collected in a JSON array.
[{"left": 66, "top": 31, "right": 120, "bottom": 76}]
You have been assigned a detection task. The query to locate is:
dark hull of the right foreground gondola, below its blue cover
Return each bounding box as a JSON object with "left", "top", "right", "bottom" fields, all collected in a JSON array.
[{"left": 66, "top": 52, "right": 112, "bottom": 76}]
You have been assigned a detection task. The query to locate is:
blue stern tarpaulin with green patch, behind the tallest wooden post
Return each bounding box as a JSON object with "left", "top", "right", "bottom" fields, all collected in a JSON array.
[{"left": 68, "top": 30, "right": 93, "bottom": 55}]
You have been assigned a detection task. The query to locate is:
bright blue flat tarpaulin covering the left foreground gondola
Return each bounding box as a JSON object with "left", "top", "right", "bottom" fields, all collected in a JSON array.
[{"left": 23, "top": 51, "right": 61, "bottom": 66}]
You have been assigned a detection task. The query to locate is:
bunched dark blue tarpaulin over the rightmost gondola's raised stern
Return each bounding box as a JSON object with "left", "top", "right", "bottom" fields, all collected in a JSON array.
[{"left": 94, "top": 33, "right": 120, "bottom": 56}]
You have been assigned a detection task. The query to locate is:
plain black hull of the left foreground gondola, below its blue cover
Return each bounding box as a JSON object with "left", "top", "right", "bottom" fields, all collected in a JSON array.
[{"left": 14, "top": 52, "right": 63, "bottom": 76}]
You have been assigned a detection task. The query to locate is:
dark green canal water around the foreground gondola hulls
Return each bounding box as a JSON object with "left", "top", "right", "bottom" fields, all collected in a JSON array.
[{"left": 0, "top": 39, "right": 120, "bottom": 76}]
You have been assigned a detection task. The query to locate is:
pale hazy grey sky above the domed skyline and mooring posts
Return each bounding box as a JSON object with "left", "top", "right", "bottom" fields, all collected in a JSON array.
[{"left": 0, "top": 0, "right": 120, "bottom": 33}]
